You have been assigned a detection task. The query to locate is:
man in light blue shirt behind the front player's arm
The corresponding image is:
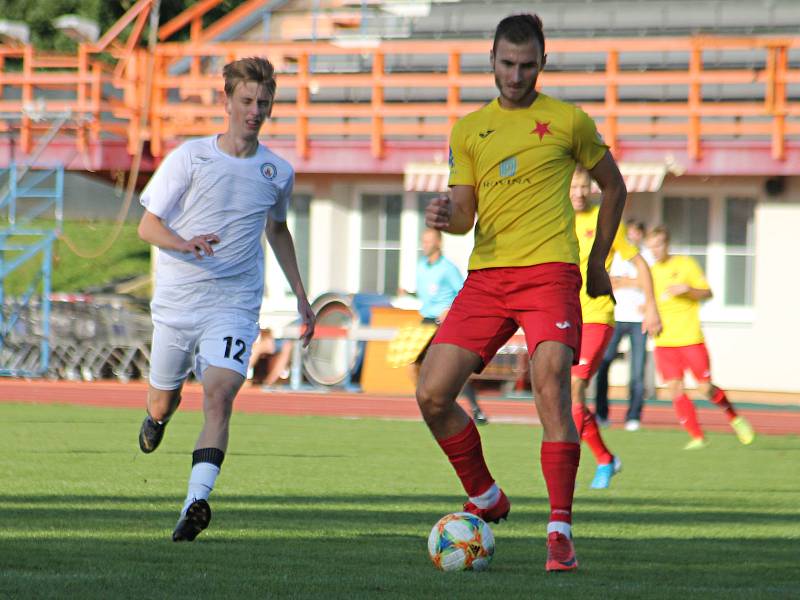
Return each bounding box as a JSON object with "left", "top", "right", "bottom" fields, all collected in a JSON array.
[{"left": 417, "top": 228, "right": 488, "bottom": 425}]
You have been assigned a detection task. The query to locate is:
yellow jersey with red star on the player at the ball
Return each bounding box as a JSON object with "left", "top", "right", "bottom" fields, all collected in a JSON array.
[{"left": 449, "top": 94, "right": 608, "bottom": 270}]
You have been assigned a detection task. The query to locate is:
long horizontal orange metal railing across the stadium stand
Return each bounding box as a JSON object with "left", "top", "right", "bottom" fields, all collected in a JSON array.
[{"left": 0, "top": 37, "right": 800, "bottom": 159}]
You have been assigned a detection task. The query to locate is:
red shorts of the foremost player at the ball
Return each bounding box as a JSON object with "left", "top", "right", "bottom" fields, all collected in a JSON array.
[{"left": 431, "top": 263, "right": 582, "bottom": 372}]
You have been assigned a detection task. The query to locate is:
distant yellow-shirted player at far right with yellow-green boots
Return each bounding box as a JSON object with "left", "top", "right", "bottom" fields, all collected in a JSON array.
[{"left": 646, "top": 226, "right": 755, "bottom": 450}]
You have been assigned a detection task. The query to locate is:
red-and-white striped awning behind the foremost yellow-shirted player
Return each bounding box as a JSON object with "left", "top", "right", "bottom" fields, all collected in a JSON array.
[{"left": 403, "top": 163, "right": 670, "bottom": 194}]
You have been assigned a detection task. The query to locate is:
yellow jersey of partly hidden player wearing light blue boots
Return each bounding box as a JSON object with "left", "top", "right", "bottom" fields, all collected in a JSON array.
[{"left": 575, "top": 206, "right": 639, "bottom": 325}]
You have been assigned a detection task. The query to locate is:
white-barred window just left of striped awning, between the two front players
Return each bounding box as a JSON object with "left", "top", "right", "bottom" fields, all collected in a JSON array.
[{"left": 359, "top": 194, "right": 403, "bottom": 295}]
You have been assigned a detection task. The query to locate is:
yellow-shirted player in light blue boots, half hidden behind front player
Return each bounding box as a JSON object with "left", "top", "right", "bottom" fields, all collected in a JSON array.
[{"left": 569, "top": 166, "right": 661, "bottom": 489}]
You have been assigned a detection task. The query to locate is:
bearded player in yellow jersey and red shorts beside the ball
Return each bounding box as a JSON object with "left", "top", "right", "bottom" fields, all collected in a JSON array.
[{"left": 417, "top": 15, "right": 626, "bottom": 571}]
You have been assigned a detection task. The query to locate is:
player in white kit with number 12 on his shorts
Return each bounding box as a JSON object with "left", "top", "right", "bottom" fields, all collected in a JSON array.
[{"left": 139, "top": 58, "right": 314, "bottom": 542}]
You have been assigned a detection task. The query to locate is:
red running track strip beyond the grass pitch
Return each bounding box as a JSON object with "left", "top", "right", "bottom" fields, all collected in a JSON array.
[{"left": 0, "top": 379, "right": 800, "bottom": 435}]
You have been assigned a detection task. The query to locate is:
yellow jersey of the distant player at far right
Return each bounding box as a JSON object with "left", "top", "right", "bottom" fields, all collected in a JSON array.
[{"left": 650, "top": 256, "right": 709, "bottom": 347}]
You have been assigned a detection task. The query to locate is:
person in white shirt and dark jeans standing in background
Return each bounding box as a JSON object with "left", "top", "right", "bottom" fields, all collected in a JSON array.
[{"left": 595, "top": 221, "right": 653, "bottom": 431}]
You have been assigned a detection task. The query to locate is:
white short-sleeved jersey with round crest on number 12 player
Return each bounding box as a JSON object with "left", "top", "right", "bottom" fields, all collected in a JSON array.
[{"left": 140, "top": 136, "right": 294, "bottom": 315}]
